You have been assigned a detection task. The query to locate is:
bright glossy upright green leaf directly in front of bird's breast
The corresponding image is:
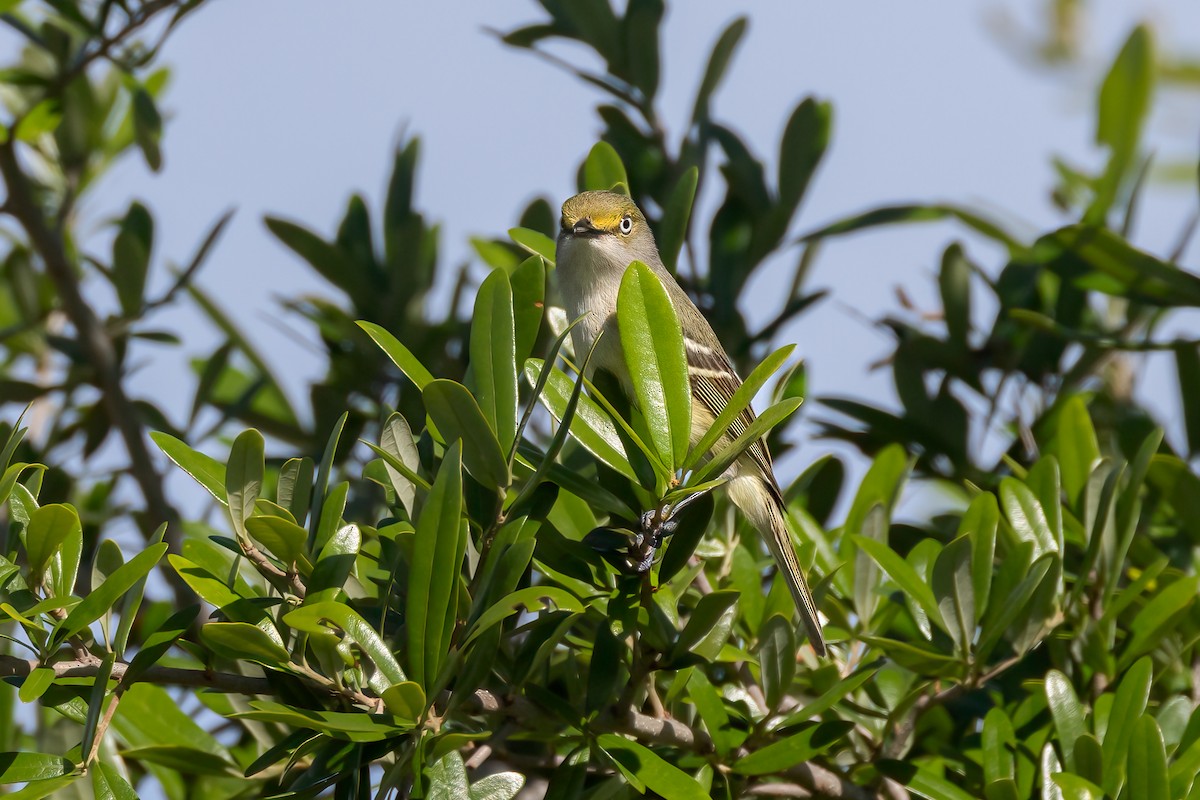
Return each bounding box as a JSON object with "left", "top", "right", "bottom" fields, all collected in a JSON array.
[{"left": 617, "top": 261, "right": 691, "bottom": 474}]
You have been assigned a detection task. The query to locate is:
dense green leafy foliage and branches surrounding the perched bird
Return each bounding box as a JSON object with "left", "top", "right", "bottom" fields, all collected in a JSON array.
[{"left": 0, "top": 0, "right": 1200, "bottom": 800}]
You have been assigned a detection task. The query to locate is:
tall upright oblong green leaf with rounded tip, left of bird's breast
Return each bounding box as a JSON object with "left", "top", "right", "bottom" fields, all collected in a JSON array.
[{"left": 470, "top": 270, "right": 517, "bottom": 452}]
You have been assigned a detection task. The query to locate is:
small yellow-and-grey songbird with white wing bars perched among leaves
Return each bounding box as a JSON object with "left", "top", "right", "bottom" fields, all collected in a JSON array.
[{"left": 556, "top": 192, "right": 826, "bottom": 655}]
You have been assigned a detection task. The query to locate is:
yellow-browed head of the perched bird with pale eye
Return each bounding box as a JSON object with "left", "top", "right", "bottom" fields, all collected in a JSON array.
[{"left": 558, "top": 192, "right": 661, "bottom": 272}]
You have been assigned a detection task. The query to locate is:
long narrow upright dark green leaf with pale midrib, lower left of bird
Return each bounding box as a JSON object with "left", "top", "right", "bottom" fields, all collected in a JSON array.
[{"left": 406, "top": 441, "right": 467, "bottom": 690}]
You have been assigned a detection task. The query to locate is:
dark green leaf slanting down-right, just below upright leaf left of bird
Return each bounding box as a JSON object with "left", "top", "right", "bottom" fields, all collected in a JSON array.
[{"left": 421, "top": 378, "right": 516, "bottom": 491}]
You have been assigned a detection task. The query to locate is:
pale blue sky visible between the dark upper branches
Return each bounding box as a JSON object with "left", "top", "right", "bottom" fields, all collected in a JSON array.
[{"left": 91, "top": 0, "right": 1200, "bottom": 506}]
